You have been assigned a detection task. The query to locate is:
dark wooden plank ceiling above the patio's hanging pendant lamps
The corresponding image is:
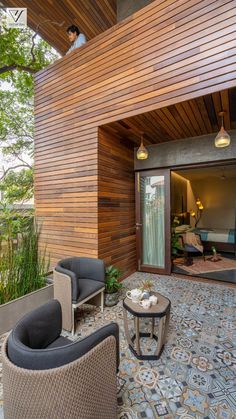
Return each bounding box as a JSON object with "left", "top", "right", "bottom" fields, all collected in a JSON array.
[{"left": 103, "top": 88, "right": 236, "bottom": 145}]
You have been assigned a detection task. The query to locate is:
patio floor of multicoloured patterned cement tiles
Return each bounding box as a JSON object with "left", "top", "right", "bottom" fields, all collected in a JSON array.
[{"left": 0, "top": 273, "right": 236, "bottom": 419}]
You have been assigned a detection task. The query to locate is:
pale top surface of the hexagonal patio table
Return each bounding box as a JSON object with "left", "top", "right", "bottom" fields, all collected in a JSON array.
[{"left": 123, "top": 292, "right": 171, "bottom": 317}]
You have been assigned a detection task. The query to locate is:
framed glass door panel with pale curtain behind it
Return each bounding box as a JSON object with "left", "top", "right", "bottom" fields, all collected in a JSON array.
[{"left": 136, "top": 169, "right": 171, "bottom": 274}]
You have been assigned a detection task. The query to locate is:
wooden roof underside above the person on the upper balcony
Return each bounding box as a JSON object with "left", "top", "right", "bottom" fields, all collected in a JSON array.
[{"left": 0, "top": 0, "right": 117, "bottom": 55}]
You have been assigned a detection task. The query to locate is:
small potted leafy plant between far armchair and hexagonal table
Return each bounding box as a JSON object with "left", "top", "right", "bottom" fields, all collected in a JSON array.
[{"left": 105, "top": 265, "right": 122, "bottom": 307}]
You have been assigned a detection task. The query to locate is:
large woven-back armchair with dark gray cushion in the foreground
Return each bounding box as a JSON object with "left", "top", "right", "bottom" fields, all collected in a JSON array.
[{"left": 2, "top": 300, "right": 119, "bottom": 419}]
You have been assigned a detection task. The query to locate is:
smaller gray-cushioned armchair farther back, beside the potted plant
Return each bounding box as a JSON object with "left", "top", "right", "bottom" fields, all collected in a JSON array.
[{"left": 53, "top": 257, "right": 105, "bottom": 334}]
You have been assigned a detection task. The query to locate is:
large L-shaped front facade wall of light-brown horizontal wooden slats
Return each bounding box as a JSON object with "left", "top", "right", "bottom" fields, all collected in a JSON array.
[{"left": 35, "top": 0, "right": 236, "bottom": 274}]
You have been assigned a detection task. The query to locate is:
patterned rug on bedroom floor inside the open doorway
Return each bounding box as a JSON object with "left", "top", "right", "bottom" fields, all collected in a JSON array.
[{"left": 174, "top": 256, "right": 236, "bottom": 274}]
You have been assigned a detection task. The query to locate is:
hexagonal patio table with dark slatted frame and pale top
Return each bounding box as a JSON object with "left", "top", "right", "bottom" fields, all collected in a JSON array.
[{"left": 123, "top": 292, "right": 171, "bottom": 360}]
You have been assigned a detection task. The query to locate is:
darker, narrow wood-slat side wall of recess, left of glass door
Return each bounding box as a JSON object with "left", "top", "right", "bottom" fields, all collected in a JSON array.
[{"left": 98, "top": 129, "right": 136, "bottom": 275}]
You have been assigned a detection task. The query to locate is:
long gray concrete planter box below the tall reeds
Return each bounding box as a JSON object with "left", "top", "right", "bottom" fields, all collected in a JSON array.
[{"left": 0, "top": 283, "right": 53, "bottom": 335}]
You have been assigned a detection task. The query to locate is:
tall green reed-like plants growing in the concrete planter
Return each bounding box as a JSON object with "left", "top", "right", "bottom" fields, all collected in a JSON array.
[{"left": 0, "top": 208, "right": 49, "bottom": 304}]
